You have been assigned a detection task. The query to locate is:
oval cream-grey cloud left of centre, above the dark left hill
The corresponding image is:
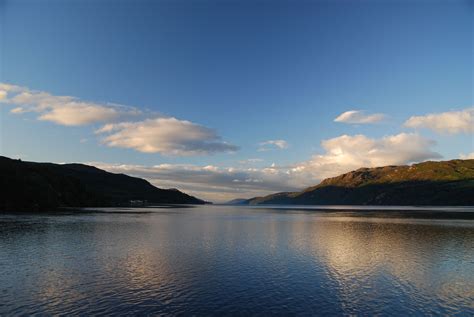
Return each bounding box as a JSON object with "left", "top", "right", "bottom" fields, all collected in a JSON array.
[{"left": 96, "top": 118, "right": 238, "bottom": 156}]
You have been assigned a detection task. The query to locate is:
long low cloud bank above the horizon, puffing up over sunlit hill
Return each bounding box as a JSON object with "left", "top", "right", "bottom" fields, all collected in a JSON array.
[{"left": 92, "top": 133, "right": 441, "bottom": 201}]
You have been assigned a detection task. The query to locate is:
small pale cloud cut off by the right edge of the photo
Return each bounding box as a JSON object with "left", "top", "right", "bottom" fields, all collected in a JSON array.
[{"left": 405, "top": 107, "right": 474, "bottom": 134}]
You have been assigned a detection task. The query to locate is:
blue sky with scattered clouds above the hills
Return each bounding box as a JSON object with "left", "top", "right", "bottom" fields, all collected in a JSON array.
[{"left": 0, "top": 0, "right": 474, "bottom": 202}]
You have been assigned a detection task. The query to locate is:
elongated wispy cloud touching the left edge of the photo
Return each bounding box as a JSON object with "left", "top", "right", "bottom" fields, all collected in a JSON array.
[{"left": 0, "top": 83, "right": 141, "bottom": 126}]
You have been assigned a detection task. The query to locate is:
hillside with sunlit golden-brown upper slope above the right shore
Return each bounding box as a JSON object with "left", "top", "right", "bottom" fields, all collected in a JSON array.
[{"left": 246, "top": 160, "right": 474, "bottom": 206}]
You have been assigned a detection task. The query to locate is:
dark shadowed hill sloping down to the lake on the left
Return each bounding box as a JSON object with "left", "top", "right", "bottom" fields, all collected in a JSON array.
[{"left": 0, "top": 156, "right": 205, "bottom": 211}]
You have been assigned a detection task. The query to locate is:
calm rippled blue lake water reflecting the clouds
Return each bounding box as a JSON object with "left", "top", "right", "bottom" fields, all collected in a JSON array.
[{"left": 0, "top": 206, "right": 474, "bottom": 316}]
